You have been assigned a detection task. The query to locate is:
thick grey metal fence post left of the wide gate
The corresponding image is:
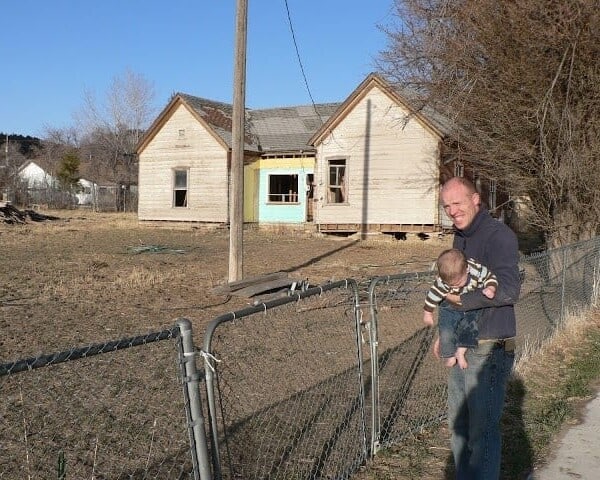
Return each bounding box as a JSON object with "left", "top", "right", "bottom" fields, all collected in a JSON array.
[{"left": 177, "top": 318, "right": 212, "bottom": 480}]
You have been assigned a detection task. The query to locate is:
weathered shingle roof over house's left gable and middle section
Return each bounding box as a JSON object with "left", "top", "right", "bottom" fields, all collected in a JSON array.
[{"left": 137, "top": 93, "right": 340, "bottom": 154}]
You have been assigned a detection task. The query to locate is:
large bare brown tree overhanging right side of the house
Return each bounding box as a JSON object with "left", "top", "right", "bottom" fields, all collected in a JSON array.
[{"left": 380, "top": 0, "right": 600, "bottom": 246}]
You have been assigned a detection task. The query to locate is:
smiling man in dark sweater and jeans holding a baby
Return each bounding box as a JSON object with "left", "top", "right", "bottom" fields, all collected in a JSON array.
[{"left": 433, "top": 177, "right": 521, "bottom": 480}]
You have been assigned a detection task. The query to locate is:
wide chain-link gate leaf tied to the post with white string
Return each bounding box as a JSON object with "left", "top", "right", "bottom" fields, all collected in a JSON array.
[{"left": 203, "top": 281, "right": 367, "bottom": 479}]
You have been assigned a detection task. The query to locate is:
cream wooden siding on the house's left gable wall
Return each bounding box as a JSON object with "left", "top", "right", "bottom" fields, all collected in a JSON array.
[{"left": 138, "top": 106, "right": 228, "bottom": 223}]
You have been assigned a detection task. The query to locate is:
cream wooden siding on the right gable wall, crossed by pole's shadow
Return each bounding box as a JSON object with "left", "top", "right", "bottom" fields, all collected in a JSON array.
[{"left": 315, "top": 87, "right": 440, "bottom": 229}]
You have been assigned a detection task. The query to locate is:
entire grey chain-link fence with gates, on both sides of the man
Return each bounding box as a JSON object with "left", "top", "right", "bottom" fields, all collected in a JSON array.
[{"left": 0, "top": 238, "right": 600, "bottom": 480}]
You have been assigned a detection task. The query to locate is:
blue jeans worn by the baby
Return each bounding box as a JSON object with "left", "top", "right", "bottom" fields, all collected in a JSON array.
[{"left": 438, "top": 301, "right": 481, "bottom": 358}]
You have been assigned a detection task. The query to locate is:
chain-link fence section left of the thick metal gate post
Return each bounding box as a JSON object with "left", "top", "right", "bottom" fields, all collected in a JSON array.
[{"left": 0, "top": 321, "right": 205, "bottom": 480}]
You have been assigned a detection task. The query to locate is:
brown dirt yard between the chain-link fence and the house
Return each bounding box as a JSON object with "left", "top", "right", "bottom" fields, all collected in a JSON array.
[{"left": 0, "top": 210, "right": 450, "bottom": 363}]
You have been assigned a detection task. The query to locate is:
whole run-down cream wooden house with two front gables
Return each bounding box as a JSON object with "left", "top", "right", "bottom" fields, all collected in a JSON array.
[{"left": 137, "top": 74, "right": 454, "bottom": 233}]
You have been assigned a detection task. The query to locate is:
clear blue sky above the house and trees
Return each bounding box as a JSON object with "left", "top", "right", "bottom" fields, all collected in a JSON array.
[{"left": 0, "top": 0, "right": 395, "bottom": 138}]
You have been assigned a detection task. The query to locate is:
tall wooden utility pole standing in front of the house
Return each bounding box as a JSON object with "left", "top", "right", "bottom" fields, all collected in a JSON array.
[{"left": 229, "top": 0, "right": 248, "bottom": 283}]
